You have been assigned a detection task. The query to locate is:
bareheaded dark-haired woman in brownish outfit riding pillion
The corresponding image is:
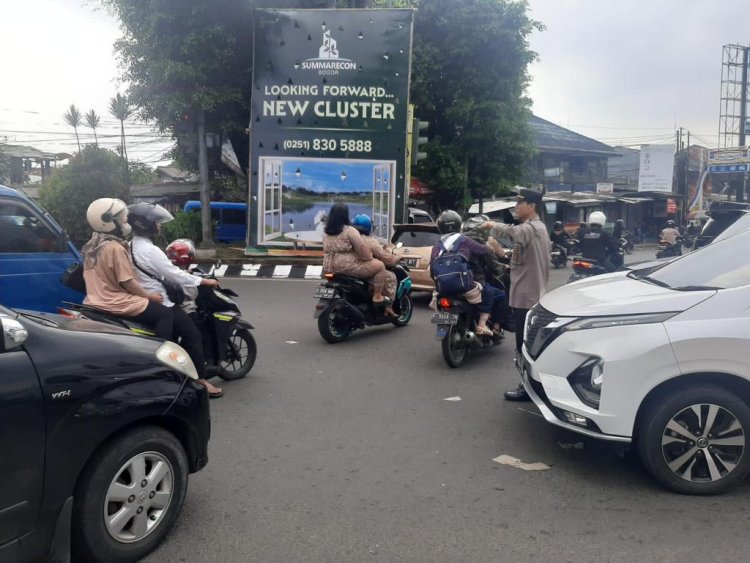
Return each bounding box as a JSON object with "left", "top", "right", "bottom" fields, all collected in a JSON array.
[{"left": 323, "top": 203, "right": 391, "bottom": 307}]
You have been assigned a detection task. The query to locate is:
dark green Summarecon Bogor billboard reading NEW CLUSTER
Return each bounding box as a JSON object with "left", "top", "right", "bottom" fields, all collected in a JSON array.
[{"left": 248, "top": 9, "right": 413, "bottom": 246}]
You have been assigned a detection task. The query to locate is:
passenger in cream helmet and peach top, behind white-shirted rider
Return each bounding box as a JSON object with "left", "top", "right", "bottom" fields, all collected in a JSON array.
[{"left": 81, "top": 197, "right": 173, "bottom": 334}]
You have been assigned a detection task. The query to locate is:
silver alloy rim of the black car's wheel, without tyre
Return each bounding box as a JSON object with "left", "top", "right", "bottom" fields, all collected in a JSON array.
[{"left": 104, "top": 452, "right": 174, "bottom": 543}]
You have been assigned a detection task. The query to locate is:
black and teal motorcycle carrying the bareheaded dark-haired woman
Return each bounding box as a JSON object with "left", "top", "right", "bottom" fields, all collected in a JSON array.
[{"left": 313, "top": 264, "right": 413, "bottom": 344}]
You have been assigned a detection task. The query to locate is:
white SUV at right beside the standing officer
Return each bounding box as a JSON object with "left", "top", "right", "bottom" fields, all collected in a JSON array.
[{"left": 519, "top": 227, "right": 750, "bottom": 494}]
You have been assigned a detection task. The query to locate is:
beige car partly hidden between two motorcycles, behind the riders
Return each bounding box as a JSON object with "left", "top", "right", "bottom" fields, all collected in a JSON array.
[{"left": 387, "top": 223, "right": 440, "bottom": 291}]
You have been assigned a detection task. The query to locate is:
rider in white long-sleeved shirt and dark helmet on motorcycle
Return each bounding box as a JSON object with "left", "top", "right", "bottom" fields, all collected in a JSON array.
[{"left": 128, "top": 203, "right": 223, "bottom": 398}]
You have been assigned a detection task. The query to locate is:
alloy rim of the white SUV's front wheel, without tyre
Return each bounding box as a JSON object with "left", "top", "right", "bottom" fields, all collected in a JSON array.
[{"left": 661, "top": 404, "right": 745, "bottom": 483}]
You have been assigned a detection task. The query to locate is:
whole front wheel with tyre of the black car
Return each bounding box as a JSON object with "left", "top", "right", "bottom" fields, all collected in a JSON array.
[{"left": 72, "top": 426, "right": 189, "bottom": 563}]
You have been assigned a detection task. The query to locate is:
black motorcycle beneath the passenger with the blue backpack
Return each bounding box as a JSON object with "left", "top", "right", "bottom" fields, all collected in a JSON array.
[{"left": 430, "top": 284, "right": 508, "bottom": 368}]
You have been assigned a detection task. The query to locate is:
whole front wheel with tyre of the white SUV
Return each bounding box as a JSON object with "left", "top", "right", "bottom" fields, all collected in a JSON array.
[{"left": 637, "top": 385, "right": 750, "bottom": 495}]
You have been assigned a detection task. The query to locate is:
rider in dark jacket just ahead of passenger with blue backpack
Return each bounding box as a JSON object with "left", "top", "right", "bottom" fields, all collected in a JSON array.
[{"left": 461, "top": 215, "right": 509, "bottom": 333}]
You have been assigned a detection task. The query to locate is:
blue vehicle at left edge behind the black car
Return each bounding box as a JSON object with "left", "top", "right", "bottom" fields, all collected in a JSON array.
[{"left": 0, "top": 186, "right": 83, "bottom": 312}]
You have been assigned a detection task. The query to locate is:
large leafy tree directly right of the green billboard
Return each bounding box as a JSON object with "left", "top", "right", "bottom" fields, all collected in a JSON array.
[{"left": 411, "top": 0, "right": 541, "bottom": 212}]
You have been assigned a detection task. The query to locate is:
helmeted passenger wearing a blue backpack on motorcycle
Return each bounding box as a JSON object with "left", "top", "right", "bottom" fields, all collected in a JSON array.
[{"left": 430, "top": 210, "right": 494, "bottom": 336}]
